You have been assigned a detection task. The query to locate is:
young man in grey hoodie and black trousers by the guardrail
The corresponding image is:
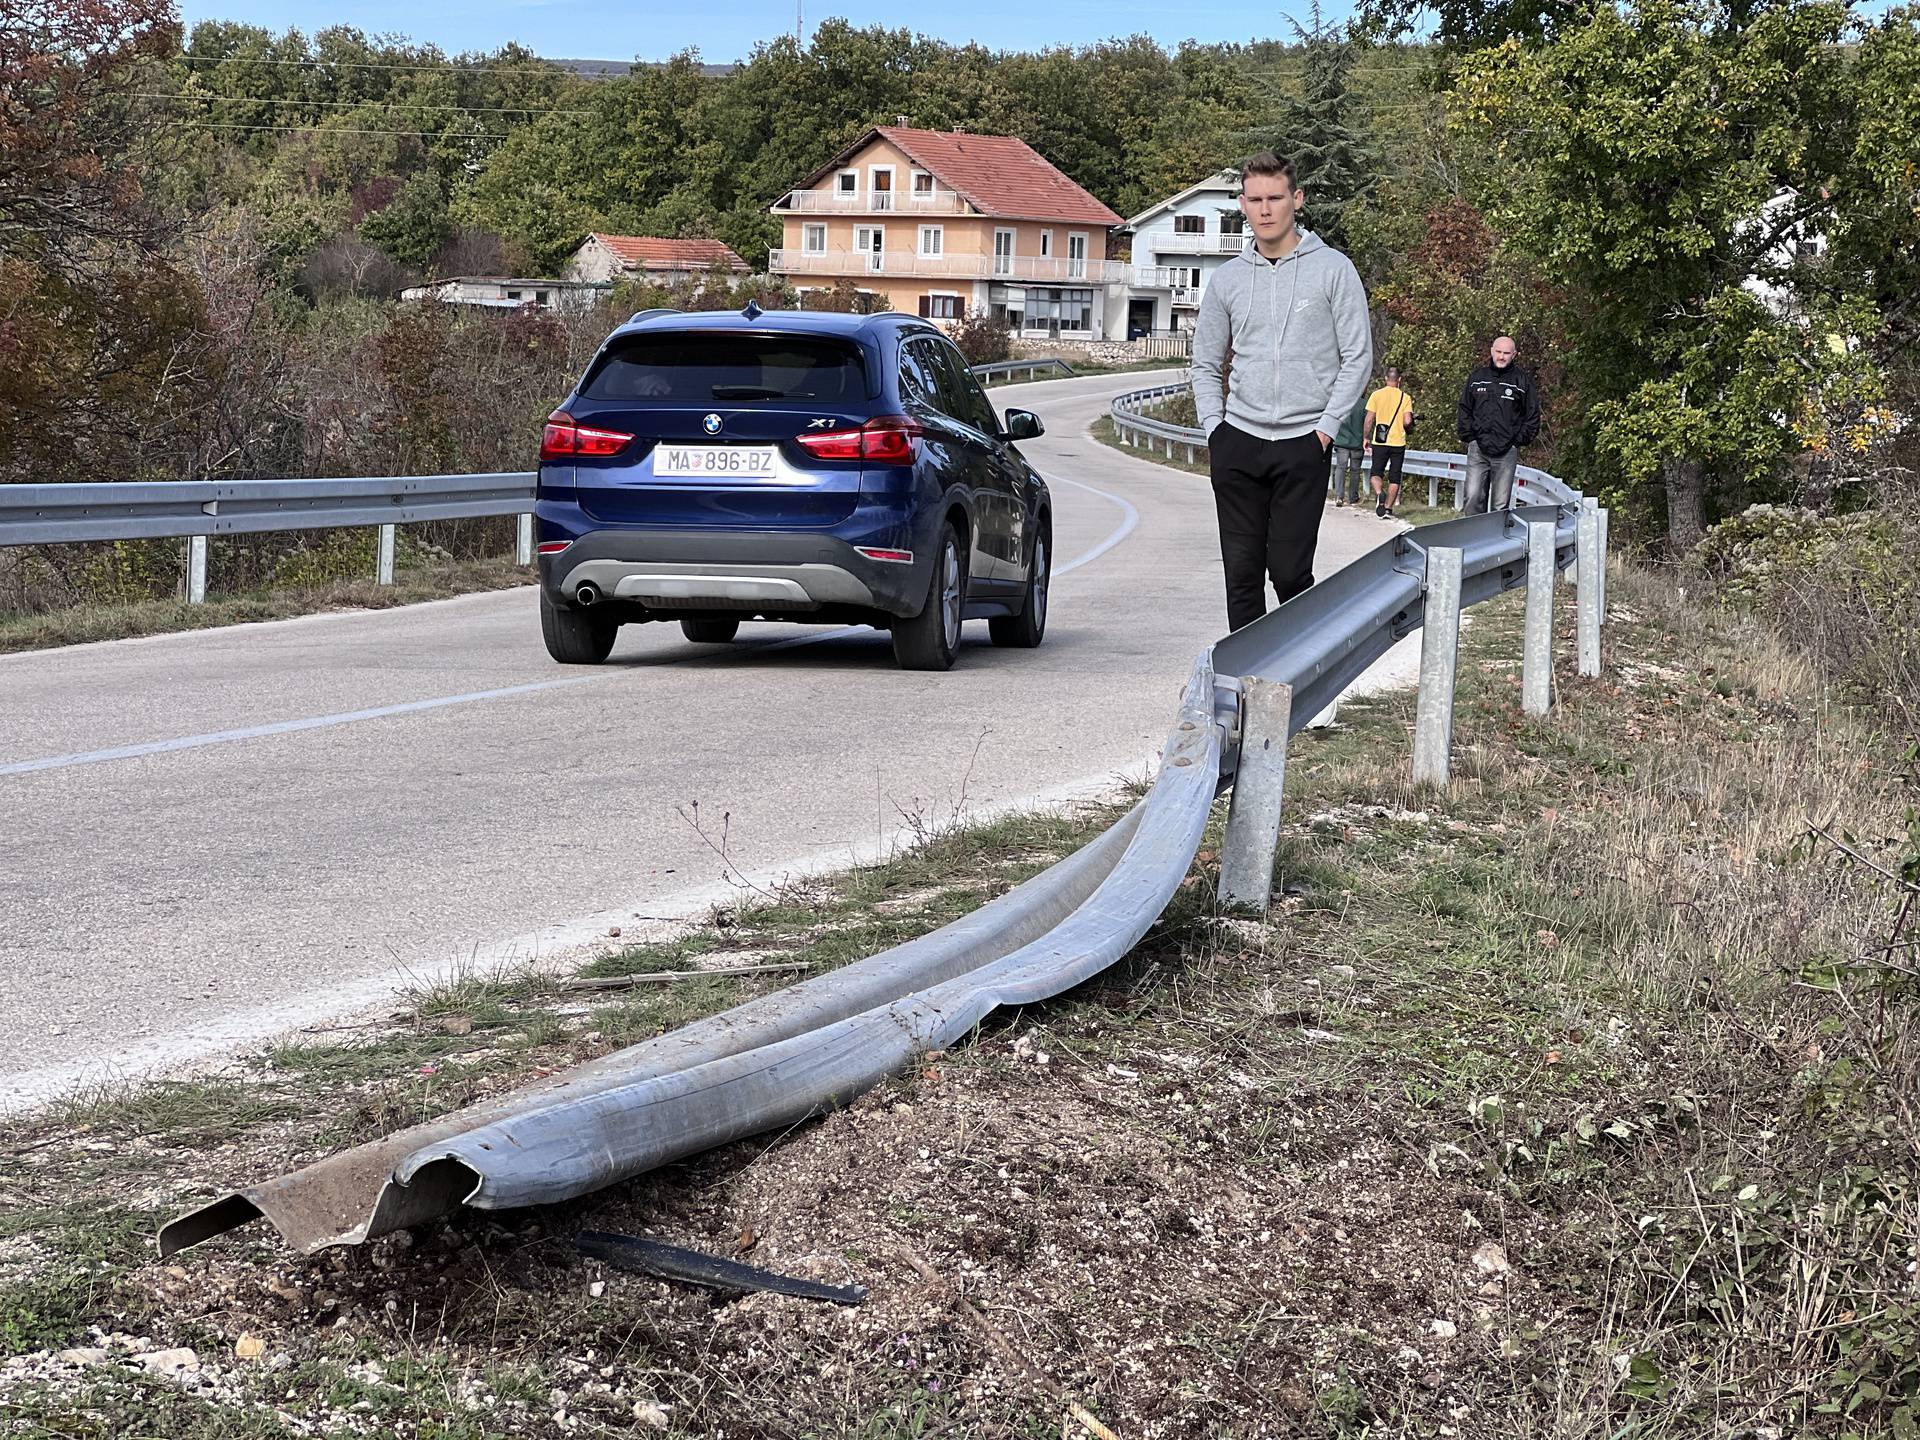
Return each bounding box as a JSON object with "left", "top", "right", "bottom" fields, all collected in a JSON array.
[{"left": 1192, "top": 150, "right": 1373, "bottom": 630}]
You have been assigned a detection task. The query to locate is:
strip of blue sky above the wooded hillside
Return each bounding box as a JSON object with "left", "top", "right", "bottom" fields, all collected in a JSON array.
[{"left": 168, "top": 0, "right": 1352, "bottom": 63}]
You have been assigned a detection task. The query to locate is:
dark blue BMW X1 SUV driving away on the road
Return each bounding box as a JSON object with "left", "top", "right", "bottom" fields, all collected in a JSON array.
[{"left": 534, "top": 305, "right": 1052, "bottom": 670}]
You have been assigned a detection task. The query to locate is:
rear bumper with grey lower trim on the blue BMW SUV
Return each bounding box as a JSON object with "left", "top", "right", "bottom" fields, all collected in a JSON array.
[{"left": 540, "top": 530, "right": 929, "bottom": 616}]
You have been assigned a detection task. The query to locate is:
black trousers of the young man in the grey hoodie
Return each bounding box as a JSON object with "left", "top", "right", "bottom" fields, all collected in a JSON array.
[{"left": 1208, "top": 422, "right": 1331, "bottom": 630}]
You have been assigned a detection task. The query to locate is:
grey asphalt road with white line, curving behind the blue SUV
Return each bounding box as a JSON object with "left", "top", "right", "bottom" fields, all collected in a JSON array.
[{"left": 0, "top": 374, "right": 1413, "bottom": 1110}]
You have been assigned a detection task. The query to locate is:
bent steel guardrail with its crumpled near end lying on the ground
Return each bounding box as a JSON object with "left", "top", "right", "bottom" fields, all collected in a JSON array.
[{"left": 159, "top": 462, "right": 1605, "bottom": 1254}]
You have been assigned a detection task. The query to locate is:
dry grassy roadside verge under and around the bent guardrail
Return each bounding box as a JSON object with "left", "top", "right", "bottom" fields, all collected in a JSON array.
[{"left": 0, "top": 570, "right": 1920, "bottom": 1440}]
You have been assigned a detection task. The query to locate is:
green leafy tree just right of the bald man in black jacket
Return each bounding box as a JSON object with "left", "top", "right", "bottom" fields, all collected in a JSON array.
[{"left": 1455, "top": 0, "right": 1873, "bottom": 553}]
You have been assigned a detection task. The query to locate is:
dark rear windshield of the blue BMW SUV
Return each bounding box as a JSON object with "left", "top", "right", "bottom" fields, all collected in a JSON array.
[{"left": 586, "top": 330, "right": 868, "bottom": 405}]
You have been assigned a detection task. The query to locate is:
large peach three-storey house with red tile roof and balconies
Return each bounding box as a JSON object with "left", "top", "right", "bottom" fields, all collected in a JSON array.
[{"left": 768, "top": 125, "right": 1129, "bottom": 340}]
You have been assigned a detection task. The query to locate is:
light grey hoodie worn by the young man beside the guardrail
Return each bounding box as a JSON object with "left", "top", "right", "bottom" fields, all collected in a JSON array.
[{"left": 1192, "top": 230, "right": 1373, "bottom": 440}]
